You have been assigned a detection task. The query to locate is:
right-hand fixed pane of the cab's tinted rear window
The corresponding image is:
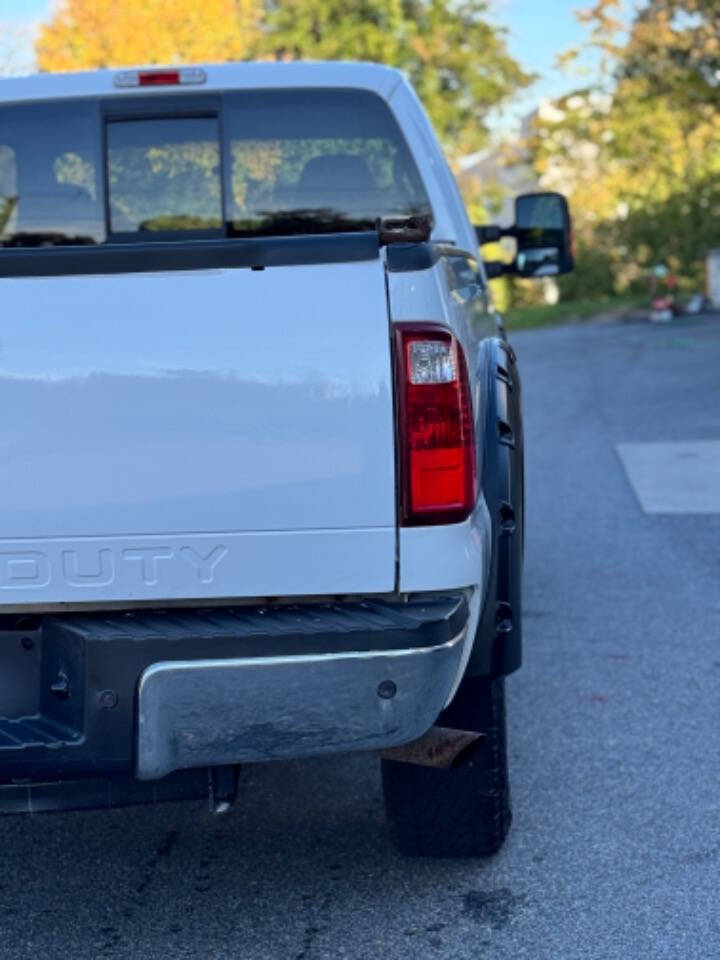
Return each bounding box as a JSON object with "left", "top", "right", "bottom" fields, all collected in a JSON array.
[{"left": 225, "top": 90, "right": 430, "bottom": 236}]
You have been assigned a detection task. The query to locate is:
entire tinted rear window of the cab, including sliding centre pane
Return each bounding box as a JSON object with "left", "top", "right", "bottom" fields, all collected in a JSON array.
[{"left": 0, "top": 89, "right": 431, "bottom": 247}]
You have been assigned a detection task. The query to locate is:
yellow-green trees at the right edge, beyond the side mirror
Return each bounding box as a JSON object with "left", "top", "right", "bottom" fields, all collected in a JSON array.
[{"left": 533, "top": 0, "right": 720, "bottom": 298}]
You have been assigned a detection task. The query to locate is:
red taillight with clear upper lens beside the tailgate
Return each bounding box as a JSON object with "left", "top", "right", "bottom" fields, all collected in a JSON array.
[{"left": 395, "top": 324, "right": 475, "bottom": 526}]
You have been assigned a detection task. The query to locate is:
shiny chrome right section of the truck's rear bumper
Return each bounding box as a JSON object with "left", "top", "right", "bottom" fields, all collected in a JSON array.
[{"left": 136, "top": 629, "right": 466, "bottom": 780}]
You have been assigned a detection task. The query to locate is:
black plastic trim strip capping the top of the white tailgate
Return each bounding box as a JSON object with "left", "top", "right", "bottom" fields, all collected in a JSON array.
[{"left": 0, "top": 231, "right": 379, "bottom": 277}]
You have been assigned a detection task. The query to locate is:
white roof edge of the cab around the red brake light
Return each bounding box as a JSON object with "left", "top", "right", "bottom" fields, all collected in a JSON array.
[{"left": 0, "top": 61, "right": 405, "bottom": 103}]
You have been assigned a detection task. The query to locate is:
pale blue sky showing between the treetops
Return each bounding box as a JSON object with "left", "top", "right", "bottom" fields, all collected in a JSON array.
[{"left": 0, "top": 0, "right": 636, "bottom": 133}]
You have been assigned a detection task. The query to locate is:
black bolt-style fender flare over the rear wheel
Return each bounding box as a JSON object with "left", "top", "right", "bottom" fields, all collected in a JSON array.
[{"left": 466, "top": 337, "right": 525, "bottom": 677}]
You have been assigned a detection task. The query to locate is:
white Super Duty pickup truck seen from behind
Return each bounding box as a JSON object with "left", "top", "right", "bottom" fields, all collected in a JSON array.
[{"left": 0, "top": 63, "right": 572, "bottom": 856}]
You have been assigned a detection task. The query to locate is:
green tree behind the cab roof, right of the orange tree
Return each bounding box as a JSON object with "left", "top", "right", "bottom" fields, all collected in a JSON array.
[{"left": 261, "top": 0, "right": 533, "bottom": 156}]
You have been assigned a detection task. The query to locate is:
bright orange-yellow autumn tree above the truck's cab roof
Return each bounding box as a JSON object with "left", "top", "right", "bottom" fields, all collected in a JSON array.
[{"left": 35, "top": 0, "right": 260, "bottom": 71}]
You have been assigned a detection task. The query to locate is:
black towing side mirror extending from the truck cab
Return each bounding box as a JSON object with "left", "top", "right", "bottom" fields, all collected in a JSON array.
[{"left": 475, "top": 193, "right": 573, "bottom": 277}]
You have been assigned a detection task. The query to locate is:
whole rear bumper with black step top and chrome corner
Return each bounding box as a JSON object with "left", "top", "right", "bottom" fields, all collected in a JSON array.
[{"left": 0, "top": 591, "right": 470, "bottom": 792}]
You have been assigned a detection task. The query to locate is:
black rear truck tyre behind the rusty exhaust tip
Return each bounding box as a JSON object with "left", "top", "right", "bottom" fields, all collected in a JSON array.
[{"left": 382, "top": 677, "right": 512, "bottom": 857}]
